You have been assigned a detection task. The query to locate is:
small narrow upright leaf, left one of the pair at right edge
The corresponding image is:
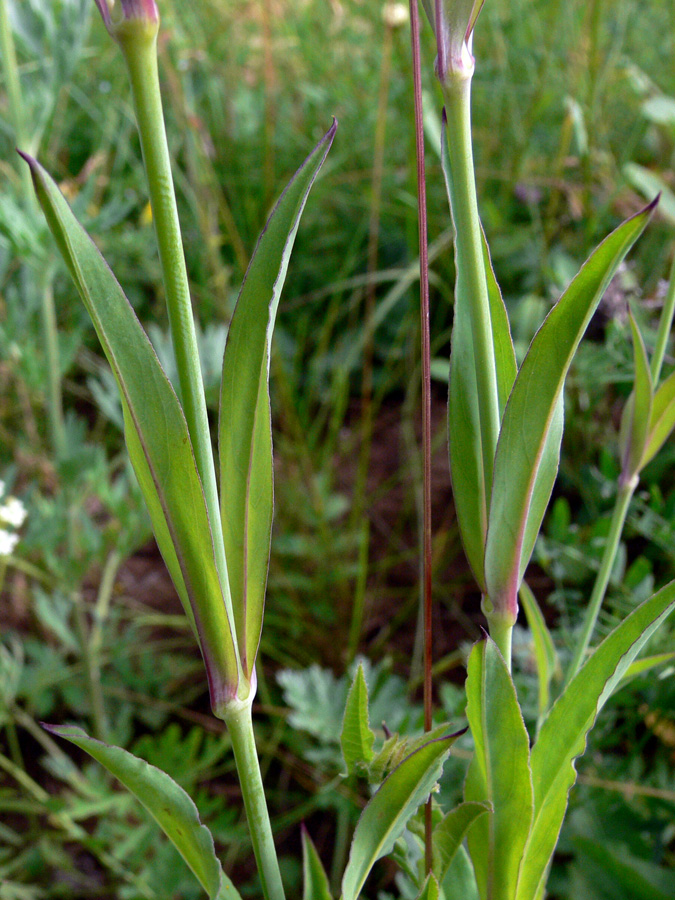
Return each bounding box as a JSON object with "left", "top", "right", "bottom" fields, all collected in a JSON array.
[{"left": 619, "top": 314, "right": 654, "bottom": 478}]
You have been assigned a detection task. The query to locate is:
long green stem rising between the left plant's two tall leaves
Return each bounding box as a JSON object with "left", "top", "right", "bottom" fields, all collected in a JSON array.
[{"left": 116, "top": 20, "right": 240, "bottom": 652}]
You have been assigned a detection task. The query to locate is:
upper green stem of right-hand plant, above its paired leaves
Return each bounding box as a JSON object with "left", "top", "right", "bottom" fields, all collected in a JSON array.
[{"left": 443, "top": 72, "right": 499, "bottom": 493}]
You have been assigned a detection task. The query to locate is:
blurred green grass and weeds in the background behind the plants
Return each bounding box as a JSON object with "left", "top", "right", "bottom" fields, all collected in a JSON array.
[{"left": 0, "top": 0, "right": 675, "bottom": 900}]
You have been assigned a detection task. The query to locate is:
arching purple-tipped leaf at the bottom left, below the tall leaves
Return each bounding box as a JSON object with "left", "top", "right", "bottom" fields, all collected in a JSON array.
[{"left": 45, "top": 725, "right": 241, "bottom": 900}]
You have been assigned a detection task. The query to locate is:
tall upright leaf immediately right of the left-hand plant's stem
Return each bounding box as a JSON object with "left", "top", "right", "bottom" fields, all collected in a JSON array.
[{"left": 218, "top": 122, "right": 337, "bottom": 677}]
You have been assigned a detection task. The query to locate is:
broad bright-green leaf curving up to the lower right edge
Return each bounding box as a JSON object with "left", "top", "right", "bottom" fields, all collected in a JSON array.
[{"left": 515, "top": 582, "right": 675, "bottom": 900}]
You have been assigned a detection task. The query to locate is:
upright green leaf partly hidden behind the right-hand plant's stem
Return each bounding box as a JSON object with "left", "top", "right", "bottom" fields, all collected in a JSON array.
[{"left": 441, "top": 117, "right": 516, "bottom": 590}]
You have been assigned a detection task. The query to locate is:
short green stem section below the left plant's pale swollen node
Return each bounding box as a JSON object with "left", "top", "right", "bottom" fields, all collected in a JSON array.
[{"left": 224, "top": 700, "right": 284, "bottom": 900}]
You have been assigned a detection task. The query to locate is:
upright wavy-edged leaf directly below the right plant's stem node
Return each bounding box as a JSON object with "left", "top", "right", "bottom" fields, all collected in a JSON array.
[{"left": 464, "top": 638, "right": 534, "bottom": 900}]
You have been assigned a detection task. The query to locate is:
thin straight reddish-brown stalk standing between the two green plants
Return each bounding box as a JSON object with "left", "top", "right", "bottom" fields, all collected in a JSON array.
[{"left": 410, "top": 0, "right": 432, "bottom": 871}]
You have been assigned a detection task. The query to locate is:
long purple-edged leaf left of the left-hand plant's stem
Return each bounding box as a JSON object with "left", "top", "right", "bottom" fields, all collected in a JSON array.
[{"left": 26, "top": 158, "right": 238, "bottom": 708}]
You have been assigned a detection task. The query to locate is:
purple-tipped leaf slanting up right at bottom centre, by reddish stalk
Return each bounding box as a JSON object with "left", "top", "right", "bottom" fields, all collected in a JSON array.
[{"left": 342, "top": 735, "right": 458, "bottom": 900}]
